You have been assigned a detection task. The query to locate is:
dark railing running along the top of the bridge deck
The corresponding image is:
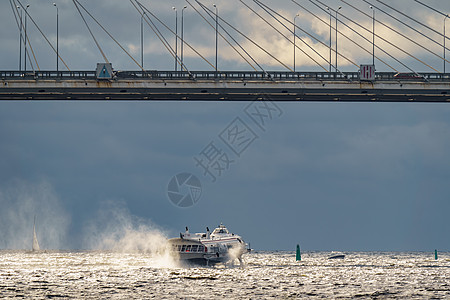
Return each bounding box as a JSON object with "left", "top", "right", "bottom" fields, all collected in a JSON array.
[{"left": 0, "top": 70, "right": 450, "bottom": 81}]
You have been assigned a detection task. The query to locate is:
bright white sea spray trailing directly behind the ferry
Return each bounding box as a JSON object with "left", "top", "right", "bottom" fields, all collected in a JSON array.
[{"left": 84, "top": 201, "right": 178, "bottom": 267}]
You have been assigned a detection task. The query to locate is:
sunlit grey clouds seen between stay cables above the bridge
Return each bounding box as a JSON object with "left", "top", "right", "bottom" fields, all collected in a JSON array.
[{"left": 0, "top": 0, "right": 448, "bottom": 72}]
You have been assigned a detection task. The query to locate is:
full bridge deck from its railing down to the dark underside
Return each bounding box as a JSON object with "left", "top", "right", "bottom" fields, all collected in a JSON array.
[{"left": 0, "top": 71, "right": 450, "bottom": 102}]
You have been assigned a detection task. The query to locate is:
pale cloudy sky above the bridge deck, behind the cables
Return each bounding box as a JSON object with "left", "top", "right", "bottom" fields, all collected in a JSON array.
[{"left": 0, "top": 0, "right": 448, "bottom": 72}]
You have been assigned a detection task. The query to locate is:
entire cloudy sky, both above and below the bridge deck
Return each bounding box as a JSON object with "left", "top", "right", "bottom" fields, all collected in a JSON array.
[{"left": 0, "top": 0, "right": 450, "bottom": 251}]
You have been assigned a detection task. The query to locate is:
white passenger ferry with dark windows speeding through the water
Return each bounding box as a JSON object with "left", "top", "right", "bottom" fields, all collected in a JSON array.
[{"left": 169, "top": 224, "right": 249, "bottom": 265}]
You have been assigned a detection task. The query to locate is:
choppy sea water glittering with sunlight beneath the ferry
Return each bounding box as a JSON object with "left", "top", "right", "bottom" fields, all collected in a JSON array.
[{"left": 0, "top": 251, "right": 450, "bottom": 299}]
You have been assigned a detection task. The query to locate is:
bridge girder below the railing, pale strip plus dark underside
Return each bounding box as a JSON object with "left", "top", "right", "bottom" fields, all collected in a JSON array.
[{"left": 0, "top": 79, "right": 450, "bottom": 102}]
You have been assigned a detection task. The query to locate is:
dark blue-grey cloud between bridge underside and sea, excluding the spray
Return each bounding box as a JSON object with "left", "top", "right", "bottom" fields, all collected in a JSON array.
[{"left": 0, "top": 103, "right": 450, "bottom": 250}]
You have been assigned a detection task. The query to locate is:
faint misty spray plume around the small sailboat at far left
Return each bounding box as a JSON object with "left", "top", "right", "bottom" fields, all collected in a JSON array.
[{"left": 0, "top": 180, "right": 70, "bottom": 250}]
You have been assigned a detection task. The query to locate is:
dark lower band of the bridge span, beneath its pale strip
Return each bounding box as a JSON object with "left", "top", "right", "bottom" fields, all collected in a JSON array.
[{"left": 0, "top": 87, "right": 450, "bottom": 102}]
